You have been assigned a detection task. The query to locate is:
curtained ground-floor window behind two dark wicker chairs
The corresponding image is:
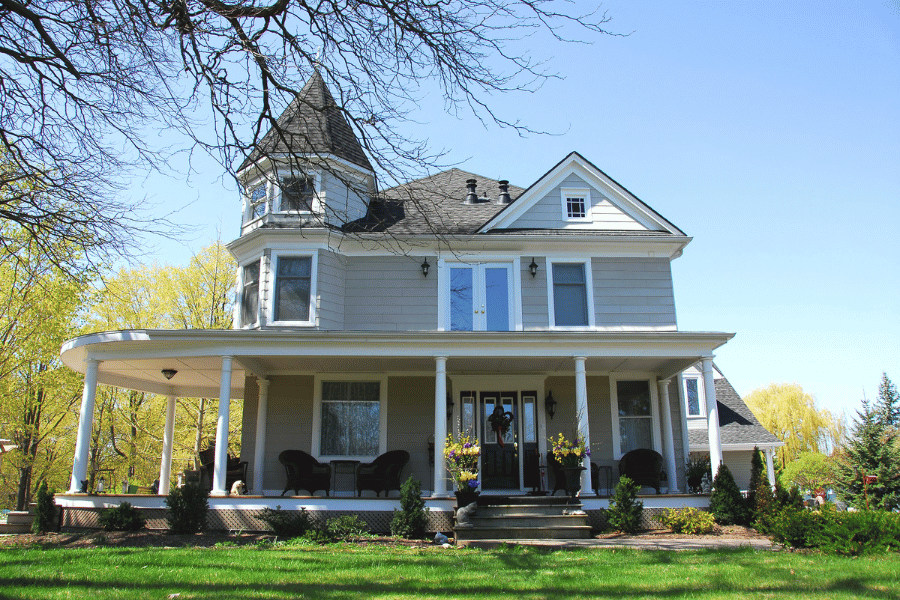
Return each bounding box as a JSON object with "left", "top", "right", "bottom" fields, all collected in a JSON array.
[{"left": 319, "top": 381, "right": 381, "bottom": 456}]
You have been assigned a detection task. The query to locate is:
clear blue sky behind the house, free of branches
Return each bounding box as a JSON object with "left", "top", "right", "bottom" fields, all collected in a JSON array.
[{"left": 134, "top": 0, "right": 900, "bottom": 414}]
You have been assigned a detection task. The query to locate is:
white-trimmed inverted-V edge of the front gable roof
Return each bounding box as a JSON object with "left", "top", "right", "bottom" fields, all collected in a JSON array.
[{"left": 478, "top": 151, "right": 685, "bottom": 236}]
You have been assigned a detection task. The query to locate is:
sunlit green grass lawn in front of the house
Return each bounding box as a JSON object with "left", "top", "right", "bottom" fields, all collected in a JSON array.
[{"left": 0, "top": 545, "right": 900, "bottom": 600}]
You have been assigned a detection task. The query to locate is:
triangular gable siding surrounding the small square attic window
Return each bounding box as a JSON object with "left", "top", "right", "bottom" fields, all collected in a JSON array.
[{"left": 510, "top": 173, "right": 647, "bottom": 230}]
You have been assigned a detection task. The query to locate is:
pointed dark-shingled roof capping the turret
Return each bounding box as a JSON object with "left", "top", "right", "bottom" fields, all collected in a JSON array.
[{"left": 238, "top": 69, "right": 374, "bottom": 171}]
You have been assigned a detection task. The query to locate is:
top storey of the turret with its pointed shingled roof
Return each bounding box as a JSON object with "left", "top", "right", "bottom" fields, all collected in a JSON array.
[{"left": 238, "top": 70, "right": 375, "bottom": 235}]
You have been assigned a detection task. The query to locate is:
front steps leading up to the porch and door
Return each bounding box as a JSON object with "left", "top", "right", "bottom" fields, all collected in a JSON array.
[{"left": 453, "top": 496, "right": 591, "bottom": 547}]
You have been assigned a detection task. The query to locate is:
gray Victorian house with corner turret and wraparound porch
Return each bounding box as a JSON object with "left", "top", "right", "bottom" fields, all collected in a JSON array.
[{"left": 57, "top": 73, "right": 760, "bottom": 524}]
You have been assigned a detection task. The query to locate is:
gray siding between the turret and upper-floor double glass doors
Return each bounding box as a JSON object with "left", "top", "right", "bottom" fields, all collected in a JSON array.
[{"left": 344, "top": 256, "right": 438, "bottom": 331}]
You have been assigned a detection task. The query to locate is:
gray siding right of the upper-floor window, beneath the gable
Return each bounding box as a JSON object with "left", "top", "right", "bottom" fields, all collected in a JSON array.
[{"left": 591, "top": 258, "right": 676, "bottom": 329}]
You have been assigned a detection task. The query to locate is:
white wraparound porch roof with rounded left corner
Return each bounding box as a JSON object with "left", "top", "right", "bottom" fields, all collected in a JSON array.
[{"left": 61, "top": 329, "right": 734, "bottom": 398}]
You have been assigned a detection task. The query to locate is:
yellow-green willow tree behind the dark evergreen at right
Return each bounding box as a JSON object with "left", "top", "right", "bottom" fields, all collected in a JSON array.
[{"left": 744, "top": 383, "right": 844, "bottom": 468}]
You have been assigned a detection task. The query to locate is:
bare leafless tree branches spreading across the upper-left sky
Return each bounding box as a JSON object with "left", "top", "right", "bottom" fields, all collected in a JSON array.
[{"left": 0, "top": 0, "right": 608, "bottom": 267}]
